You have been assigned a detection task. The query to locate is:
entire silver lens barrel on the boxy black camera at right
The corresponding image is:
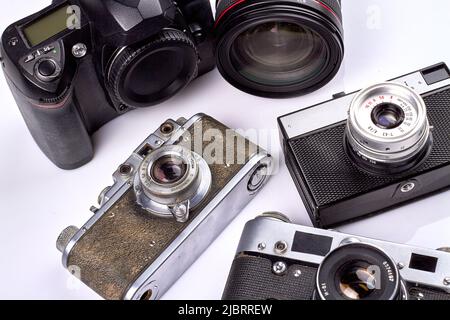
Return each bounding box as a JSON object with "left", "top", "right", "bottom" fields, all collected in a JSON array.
[{"left": 346, "top": 83, "right": 432, "bottom": 175}]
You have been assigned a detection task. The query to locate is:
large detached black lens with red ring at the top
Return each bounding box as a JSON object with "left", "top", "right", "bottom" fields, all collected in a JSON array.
[{"left": 216, "top": 0, "right": 343, "bottom": 97}]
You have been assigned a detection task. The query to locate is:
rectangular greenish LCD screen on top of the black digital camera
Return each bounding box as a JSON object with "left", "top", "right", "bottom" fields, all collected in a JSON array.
[{"left": 23, "top": 5, "right": 73, "bottom": 47}]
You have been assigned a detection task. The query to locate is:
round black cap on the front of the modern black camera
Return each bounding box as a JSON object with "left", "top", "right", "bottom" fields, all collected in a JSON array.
[{"left": 107, "top": 29, "right": 198, "bottom": 108}]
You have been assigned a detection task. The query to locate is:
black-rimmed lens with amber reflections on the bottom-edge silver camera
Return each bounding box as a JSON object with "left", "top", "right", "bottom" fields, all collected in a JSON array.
[{"left": 316, "top": 243, "right": 405, "bottom": 300}]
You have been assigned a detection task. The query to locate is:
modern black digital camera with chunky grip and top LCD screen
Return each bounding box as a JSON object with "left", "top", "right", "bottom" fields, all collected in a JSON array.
[{"left": 1, "top": 0, "right": 214, "bottom": 169}]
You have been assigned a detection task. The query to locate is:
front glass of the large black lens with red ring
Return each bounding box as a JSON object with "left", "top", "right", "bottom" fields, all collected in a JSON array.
[{"left": 231, "top": 21, "right": 328, "bottom": 86}]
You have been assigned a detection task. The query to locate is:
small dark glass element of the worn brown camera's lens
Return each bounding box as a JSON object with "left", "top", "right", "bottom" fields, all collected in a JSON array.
[{"left": 151, "top": 155, "right": 187, "bottom": 184}]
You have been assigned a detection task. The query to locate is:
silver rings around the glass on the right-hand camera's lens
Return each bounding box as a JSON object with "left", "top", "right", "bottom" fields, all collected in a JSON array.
[{"left": 346, "top": 82, "right": 431, "bottom": 163}]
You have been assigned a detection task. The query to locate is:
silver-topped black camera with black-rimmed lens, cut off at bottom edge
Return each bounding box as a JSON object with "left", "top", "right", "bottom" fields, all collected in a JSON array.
[{"left": 223, "top": 213, "right": 450, "bottom": 300}]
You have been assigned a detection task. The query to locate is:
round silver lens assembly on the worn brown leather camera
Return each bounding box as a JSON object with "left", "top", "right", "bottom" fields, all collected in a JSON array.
[{"left": 134, "top": 145, "right": 212, "bottom": 220}]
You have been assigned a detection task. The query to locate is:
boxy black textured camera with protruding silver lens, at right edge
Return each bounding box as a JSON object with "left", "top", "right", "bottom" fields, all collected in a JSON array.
[{"left": 278, "top": 63, "right": 450, "bottom": 227}]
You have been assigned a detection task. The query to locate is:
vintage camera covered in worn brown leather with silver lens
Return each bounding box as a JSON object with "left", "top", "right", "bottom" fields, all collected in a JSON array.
[{"left": 57, "top": 114, "right": 272, "bottom": 300}]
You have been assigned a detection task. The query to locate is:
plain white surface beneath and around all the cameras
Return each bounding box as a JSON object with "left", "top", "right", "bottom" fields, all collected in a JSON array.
[{"left": 0, "top": 0, "right": 450, "bottom": 299}]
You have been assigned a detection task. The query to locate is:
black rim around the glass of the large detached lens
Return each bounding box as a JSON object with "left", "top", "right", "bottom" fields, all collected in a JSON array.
[{"left": 216, "top": 4, "right": 344, "bottom": 98}]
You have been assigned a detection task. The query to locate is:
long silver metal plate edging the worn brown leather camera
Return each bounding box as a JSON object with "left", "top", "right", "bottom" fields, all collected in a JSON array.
[{"left": 124, "top": 152, "right": 272, "bottom": 300}]
